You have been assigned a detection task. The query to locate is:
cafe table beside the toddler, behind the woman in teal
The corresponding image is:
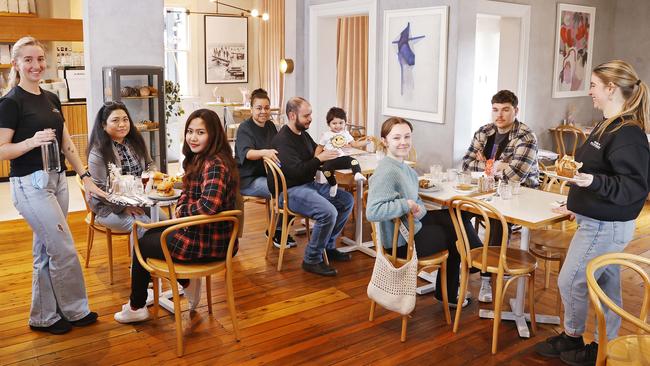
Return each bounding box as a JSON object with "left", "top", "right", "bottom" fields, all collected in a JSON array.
[{"left": 336, "top": 152, "right": 415, "bottom": 257}]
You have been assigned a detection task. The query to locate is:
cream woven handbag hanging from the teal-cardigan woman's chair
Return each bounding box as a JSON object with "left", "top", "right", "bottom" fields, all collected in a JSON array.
[{"left": 368, "top": 223, "right": 418, "bottom": 315}]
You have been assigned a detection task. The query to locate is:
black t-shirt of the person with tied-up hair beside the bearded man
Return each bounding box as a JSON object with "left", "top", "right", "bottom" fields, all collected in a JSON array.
[{"left": 235, "top": 118, "right": 278, "bottom": 188}]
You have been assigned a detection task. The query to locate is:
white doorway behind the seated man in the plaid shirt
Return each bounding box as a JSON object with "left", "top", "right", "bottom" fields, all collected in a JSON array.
[{"left": 472, "top": 0, "right": 530, "bottom": 131}]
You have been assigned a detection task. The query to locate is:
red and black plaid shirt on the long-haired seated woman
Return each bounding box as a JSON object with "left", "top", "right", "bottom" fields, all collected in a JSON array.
[{"left": 169, "top": 156, "right": 238, "bottom": 261}]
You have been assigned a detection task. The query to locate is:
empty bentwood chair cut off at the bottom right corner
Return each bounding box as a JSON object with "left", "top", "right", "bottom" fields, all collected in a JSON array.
[{"left": 587, "top": 253, "right": 650, "bottom": 366}]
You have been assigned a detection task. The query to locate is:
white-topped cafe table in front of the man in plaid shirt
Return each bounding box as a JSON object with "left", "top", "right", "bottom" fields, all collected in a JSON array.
[{"left": 420, "top": 187, "right": 570, "bottom": 338}]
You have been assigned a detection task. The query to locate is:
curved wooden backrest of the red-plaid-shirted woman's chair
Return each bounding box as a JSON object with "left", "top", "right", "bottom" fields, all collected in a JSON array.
[{"left": 132, "top": 210, "right": 242, "bottom": 280}]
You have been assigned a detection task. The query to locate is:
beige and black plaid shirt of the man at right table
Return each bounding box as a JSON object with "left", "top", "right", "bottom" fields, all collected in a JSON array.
[{"left": 463, "top": 120, "right": 539, "bottom": 188}]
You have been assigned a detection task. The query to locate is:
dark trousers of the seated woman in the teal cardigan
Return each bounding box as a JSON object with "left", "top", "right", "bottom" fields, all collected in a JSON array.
[{"left": 389, "top": 210, "right": 481, "bottom": 303}]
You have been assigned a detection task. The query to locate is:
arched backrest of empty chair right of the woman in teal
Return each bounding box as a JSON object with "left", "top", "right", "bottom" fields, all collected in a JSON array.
[{"left": 449, "top": 196, "right": 509, "bottom": 273}]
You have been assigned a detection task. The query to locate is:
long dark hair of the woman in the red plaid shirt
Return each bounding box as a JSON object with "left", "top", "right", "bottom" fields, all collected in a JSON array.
[{"left": 183, "top": 109, "right": 239, "bottom": 187}]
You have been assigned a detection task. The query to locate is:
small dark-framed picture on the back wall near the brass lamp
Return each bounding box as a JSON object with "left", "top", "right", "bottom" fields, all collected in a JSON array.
[{"left": 203, "top": 15, "right": 248, "bottom": 84}]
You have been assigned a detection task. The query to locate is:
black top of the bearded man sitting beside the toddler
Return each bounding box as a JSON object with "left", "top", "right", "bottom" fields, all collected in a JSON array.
[{"left": 271, "top": 126, "right": 321, "bottom": 188}]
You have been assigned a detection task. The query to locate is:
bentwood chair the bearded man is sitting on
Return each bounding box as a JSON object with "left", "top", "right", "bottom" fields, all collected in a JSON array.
[{"left": 264, "top": 158, "right": 320, "bottom": 271}]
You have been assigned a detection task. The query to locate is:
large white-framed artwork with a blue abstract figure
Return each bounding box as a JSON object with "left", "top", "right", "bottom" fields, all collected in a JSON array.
[{"left": 382, "top": 6, "right": 449, "bottom": 123}]
